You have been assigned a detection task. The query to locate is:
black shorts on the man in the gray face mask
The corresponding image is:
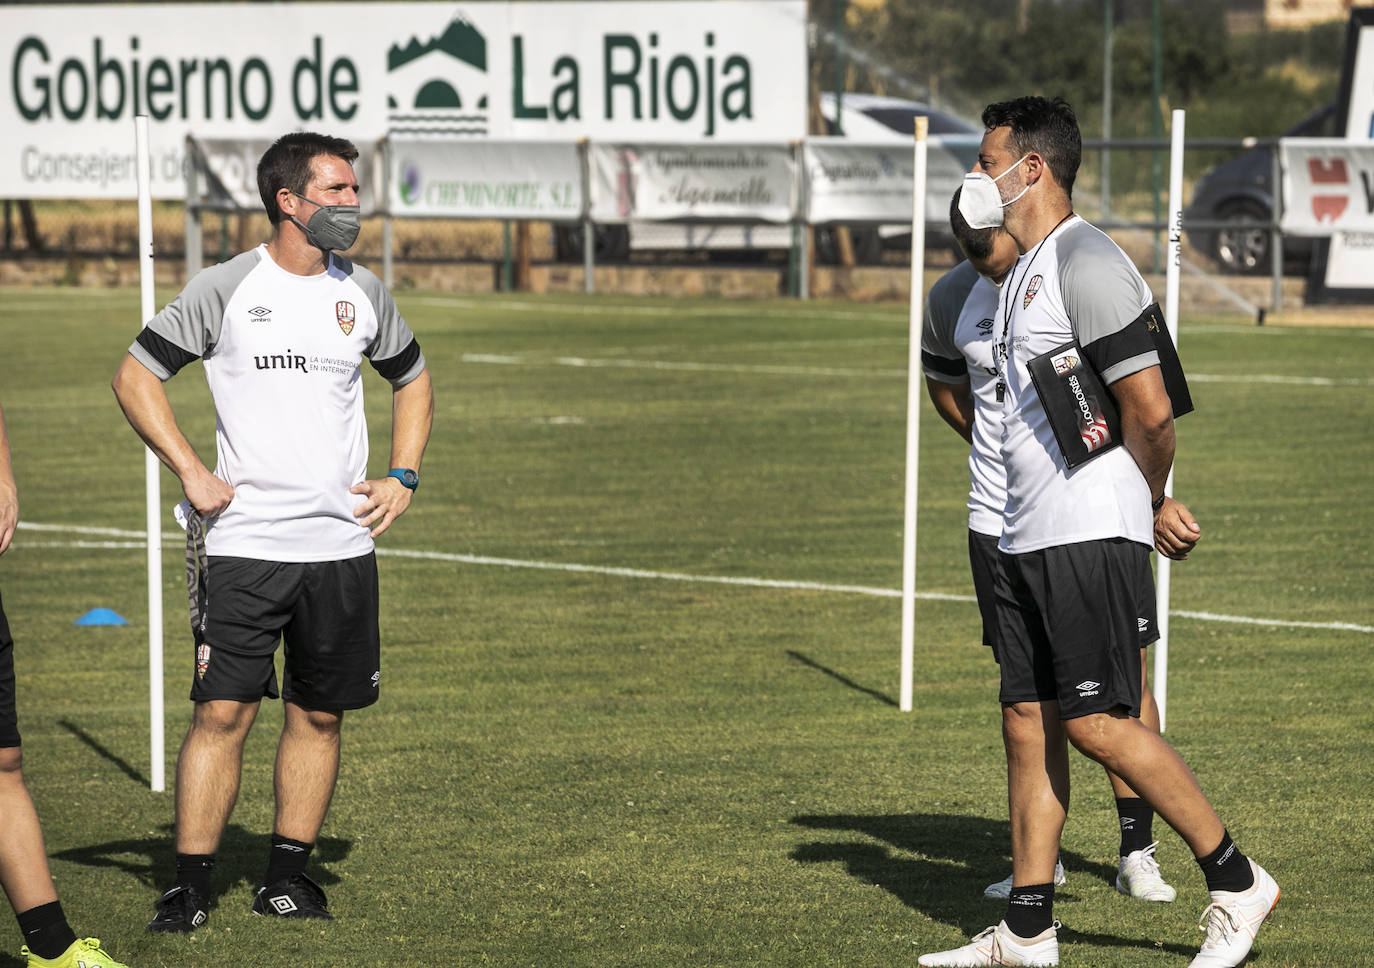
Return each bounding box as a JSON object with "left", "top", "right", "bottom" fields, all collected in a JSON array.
[{"left": 191, "top": 555, "right": 382, "bottom": 710}]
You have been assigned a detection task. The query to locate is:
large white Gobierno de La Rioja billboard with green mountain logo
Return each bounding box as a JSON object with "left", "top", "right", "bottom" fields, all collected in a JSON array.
[{"left": 0, "top": 0, "right": 807, "bottom": 198}]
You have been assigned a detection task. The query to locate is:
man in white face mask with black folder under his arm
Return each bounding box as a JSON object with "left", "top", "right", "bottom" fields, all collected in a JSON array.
[{"left": 919, "top": 97, "right": 1279, "bottom": 968}]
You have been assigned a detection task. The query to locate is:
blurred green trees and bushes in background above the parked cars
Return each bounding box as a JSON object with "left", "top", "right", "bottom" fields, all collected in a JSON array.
[{"left": 812, "top": 0, "right": 1344, "bottom": 137}]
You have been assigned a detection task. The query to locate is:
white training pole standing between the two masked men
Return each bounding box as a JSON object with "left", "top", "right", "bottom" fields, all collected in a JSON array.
[{"left": 899, "top": 118, "right": 929, "bottom": 713}]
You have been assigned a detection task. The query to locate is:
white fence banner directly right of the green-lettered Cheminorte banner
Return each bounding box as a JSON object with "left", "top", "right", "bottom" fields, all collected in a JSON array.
[{"left": 587, "top": 143, "right": 798, "bottom": 222}]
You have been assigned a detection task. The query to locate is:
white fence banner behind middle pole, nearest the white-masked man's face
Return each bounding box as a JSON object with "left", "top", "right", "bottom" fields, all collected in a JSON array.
[{"left": 804, "top": 136, "right": 980, "bottom": 225}]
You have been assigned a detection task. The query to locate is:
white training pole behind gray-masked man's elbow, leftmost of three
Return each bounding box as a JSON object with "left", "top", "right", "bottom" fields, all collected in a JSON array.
[{"left": 133, "top": 114, "right": 166, "bottom": 794}]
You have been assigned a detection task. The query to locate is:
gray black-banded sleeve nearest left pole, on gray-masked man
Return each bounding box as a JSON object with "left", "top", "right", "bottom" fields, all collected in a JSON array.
[{"left": 129, "top": 253, "right": 258, "bottom": 380}]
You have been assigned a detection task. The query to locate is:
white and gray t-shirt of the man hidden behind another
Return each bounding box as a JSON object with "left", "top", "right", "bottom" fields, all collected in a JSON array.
[{"left": 921, "top": 262, "right": 1007, "bottom": 537}]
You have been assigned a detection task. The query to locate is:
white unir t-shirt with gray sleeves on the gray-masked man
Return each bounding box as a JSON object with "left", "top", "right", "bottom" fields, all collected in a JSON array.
[{"left": 129, "top": 246, "right": 425, "bottom": 562}]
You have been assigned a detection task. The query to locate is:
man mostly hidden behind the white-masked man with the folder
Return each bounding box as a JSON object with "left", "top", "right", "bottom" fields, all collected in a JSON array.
[{"left": 921, "top": 188, "right": 1175, "bottom": 902}]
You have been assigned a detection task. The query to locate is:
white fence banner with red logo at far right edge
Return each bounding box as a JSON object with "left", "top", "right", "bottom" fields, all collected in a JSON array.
[{"left": 1279, "top": 137, "right": 1374, "bottom": 236}]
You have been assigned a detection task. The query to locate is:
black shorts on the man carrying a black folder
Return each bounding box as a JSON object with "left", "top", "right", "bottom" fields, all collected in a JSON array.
[{"left": 995, "top": 538, "right": 1158, "bottom": 719}]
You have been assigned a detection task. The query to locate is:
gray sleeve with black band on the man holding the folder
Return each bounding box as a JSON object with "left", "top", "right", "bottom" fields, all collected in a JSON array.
[{"left": 1059, "top": 227, "right": 1160, "bottom": 386}]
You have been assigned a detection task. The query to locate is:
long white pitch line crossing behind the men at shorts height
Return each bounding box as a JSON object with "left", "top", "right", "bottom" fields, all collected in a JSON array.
[{"left": 18, "top": 520, "right": 1374, "bottom": 634}]
